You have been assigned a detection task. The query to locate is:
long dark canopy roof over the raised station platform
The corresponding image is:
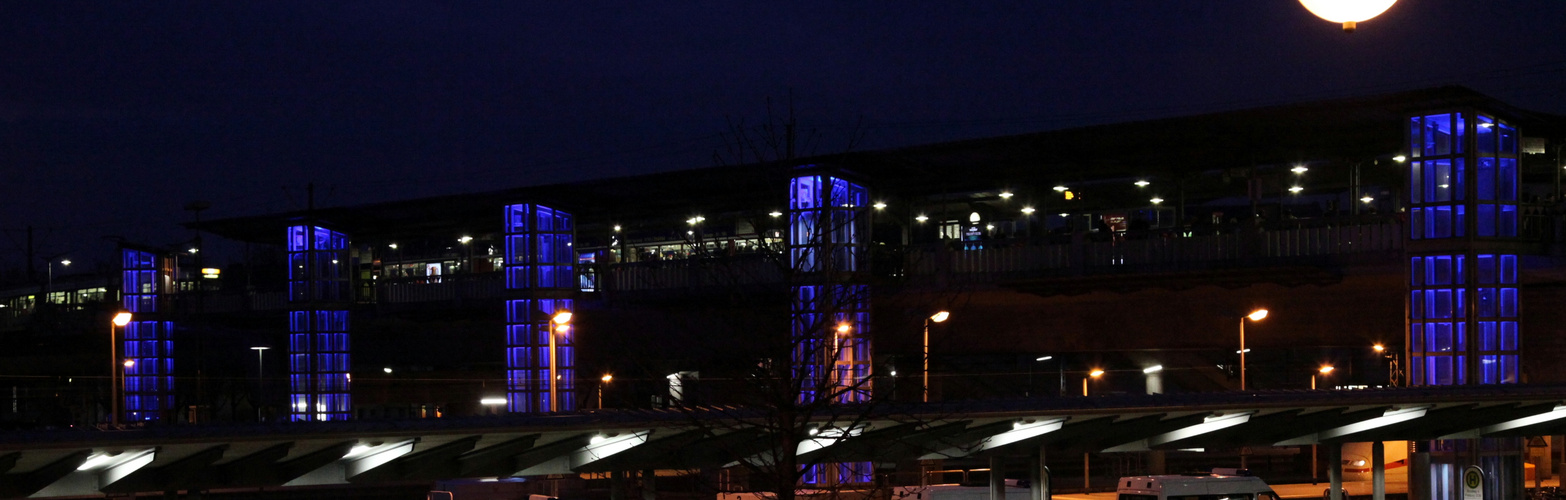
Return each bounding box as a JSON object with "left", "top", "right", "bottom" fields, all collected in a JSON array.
[{"left": 198, "top": 86, "right": 1566, "bottom": 243}]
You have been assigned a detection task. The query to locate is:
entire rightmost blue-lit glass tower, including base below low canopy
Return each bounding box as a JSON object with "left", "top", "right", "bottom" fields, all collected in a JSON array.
[{"left": 1408, "top": 110, "right": 1524, "bottom": 498}]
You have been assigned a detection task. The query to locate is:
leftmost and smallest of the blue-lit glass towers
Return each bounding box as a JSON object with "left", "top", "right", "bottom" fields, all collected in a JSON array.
[{"left": 121, "top": 248, "right": 174, "bottom": 422}]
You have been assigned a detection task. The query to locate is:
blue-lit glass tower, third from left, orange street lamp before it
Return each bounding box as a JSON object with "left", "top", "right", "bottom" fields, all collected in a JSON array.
[{"left": 504, "top": 204, "right": 576, "bottom": 412}]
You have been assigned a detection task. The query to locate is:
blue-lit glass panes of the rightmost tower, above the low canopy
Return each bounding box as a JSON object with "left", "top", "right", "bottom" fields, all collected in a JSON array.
[{"left": 1408, "top": 113, "right": 1519, "bottom": 386}]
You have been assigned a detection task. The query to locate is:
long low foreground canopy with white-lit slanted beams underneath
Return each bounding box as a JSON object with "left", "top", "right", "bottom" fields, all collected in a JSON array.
[{"left": 0, "top": 386, "right": 1566, "bottom": 498}]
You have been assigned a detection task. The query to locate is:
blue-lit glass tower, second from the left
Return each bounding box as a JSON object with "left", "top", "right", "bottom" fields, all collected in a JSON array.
[{"left": 288, "top": 224, "right": 354, "bottom": 422}]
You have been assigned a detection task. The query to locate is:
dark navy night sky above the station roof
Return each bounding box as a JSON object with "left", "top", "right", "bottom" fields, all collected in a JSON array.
[{"left": 0, "top": 0, "right": 1566, "bottom": 273}]
